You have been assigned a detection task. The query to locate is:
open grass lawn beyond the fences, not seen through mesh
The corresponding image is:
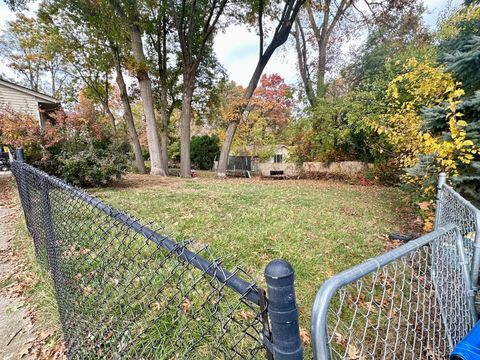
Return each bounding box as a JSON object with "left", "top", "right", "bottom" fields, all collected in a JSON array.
[{"left": 90, "top": 173, "right": 418, "bottom": 336}]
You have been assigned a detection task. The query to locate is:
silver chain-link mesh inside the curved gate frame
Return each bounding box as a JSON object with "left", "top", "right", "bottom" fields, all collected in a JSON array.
[{"left": 320, "top": 229, "right": 473, "bottom": 359}]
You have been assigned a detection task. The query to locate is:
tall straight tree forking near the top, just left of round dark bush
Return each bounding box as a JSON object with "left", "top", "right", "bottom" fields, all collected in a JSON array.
[{"left": 169, "top": 0, "right": 228, "bottom": 177}]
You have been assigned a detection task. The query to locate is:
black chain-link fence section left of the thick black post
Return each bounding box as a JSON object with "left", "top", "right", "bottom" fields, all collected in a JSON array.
[{"left": 12, "top": 162, "right": 268, "bottom": 359}]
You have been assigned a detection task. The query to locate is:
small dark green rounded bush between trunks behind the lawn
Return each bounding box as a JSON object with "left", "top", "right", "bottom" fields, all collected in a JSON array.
[{"left": 190, "top": 135, "right": 220, "bottom": 170}]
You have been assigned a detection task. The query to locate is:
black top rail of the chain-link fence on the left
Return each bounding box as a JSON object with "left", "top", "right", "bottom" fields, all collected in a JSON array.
[{"left": 13, "top": 160, "right": 261, "bottom": 305}]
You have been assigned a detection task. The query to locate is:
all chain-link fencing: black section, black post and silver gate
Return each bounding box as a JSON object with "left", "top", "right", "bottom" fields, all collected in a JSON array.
[{"left": 12, "top": 161, "right": 480, "bottom": 360}]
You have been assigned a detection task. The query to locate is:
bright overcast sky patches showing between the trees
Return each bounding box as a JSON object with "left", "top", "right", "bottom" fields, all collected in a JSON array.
[{"left": 0, "top": 0, "right": 461, "bottom": 86}]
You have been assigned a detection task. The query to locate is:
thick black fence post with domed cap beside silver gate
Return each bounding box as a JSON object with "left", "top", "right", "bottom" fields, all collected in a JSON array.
[{"left": 265, "top": 260, "right": 302, "bottom": 360}]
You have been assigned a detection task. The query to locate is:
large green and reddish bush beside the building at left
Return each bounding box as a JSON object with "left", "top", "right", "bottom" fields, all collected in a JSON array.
[{"left": 0, "top": 100, "right": 130, "bottom": 186}]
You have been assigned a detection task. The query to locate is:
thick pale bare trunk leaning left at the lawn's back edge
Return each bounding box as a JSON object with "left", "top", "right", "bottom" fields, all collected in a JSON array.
[{"left": 130, "top": 24, "right": 167, "bottom": 176}]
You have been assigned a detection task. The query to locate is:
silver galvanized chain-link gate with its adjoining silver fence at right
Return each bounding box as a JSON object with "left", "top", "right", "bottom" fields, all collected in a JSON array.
[{"left": 311, "top": 174, "right": 480, "bottom": 360}]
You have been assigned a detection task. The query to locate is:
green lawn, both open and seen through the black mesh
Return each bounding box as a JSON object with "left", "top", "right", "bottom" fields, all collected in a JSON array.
[{"left": 13, "top": 173, "right": 409, "bottom": 358}]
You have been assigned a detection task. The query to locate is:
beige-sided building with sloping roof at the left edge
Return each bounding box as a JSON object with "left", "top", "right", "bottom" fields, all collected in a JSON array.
[{"left": 0, "top": 79, "right": 60, "bottom": 127}]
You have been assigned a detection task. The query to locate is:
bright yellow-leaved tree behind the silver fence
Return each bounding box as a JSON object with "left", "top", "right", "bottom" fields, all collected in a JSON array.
[{"left": 370, "top": 59, "right": 479, "bottom": 230}]
